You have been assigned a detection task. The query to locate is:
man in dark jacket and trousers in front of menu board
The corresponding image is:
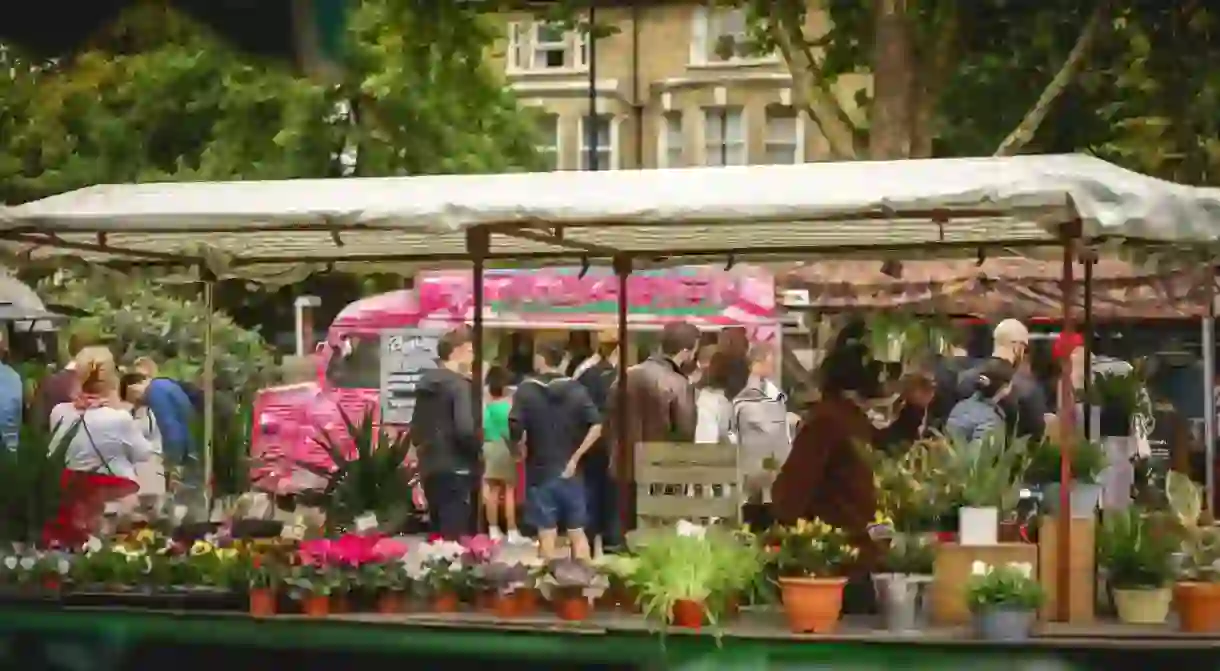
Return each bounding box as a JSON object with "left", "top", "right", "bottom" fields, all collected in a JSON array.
[{"left": 411, "top": 327, "right": 483, "bottom": 540}]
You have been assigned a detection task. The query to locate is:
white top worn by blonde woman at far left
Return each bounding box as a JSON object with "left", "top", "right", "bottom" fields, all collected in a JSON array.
[{"left": 50, "top": 403, "right": 153, "bottom": 481}]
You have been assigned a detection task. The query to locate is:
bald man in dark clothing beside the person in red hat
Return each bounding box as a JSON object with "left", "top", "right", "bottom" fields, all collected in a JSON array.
[{"left": 958, "top": 320, "right": 1047, "bottom": 440}]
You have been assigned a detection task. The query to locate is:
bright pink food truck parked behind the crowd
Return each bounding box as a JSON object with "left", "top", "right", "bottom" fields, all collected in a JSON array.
[{"left": 251, "top": 266, "right": 780, "bottom": 504}]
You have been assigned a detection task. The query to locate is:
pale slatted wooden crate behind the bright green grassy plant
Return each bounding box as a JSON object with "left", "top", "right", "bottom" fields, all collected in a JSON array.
[{"left": 636, "top": 443, "right": 743, "bottom": 528}]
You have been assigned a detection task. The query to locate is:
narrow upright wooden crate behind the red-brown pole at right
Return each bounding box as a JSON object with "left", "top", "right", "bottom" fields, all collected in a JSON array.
[{"left": 1038, "top": 517, "right": 1097, "bottom": 623}]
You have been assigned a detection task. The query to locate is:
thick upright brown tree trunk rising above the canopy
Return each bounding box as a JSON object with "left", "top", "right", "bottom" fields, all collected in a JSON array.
[{"left": 869, "top": 0, "right": 916, "bottom": 160}]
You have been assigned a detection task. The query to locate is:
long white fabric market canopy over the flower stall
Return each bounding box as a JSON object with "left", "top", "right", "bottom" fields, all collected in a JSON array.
[{"left": 0, "top": 155, "right": 1220, "bottom": 281}]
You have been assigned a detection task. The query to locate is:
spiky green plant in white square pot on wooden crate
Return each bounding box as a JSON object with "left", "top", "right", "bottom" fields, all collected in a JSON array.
[{"left": 936, "top": 432, "right": 1028, "bottom": 545}]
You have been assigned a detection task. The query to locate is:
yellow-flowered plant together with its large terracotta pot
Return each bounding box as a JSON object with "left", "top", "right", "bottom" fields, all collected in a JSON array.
[{"left": 764, "top": 520, "right": 860, "bottom": 633}]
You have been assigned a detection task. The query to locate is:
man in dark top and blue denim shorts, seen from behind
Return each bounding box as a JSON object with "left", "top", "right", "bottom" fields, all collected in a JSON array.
[{"left": 509, "top": 343, "right": 601, "bottom": 560}]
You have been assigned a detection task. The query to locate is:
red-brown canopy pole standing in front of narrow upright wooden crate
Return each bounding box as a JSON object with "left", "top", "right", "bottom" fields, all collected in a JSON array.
[{"left": 1055, "top": 220, "right": 1088, "bottom": 622}]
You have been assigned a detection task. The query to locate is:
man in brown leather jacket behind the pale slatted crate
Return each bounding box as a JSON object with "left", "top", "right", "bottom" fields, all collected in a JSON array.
[{"left": 606, "top": 323, "right": 699, "bottom": 526}]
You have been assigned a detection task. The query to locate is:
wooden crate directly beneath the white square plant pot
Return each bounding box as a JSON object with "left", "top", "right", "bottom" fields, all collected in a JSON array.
[{"left": 931, "top": 543, "right": 1038, "bottom": 625}]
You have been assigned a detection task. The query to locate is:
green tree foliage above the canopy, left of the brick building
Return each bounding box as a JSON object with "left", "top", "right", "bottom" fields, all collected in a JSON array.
[{"left": 0, "top": 0, "right": 537, "bottom": 203}]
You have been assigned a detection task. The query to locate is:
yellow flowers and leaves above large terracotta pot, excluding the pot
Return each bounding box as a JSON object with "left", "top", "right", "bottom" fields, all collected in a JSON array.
[{"left": 763, "top": 519, "right": 860, "bottom": 578}]
